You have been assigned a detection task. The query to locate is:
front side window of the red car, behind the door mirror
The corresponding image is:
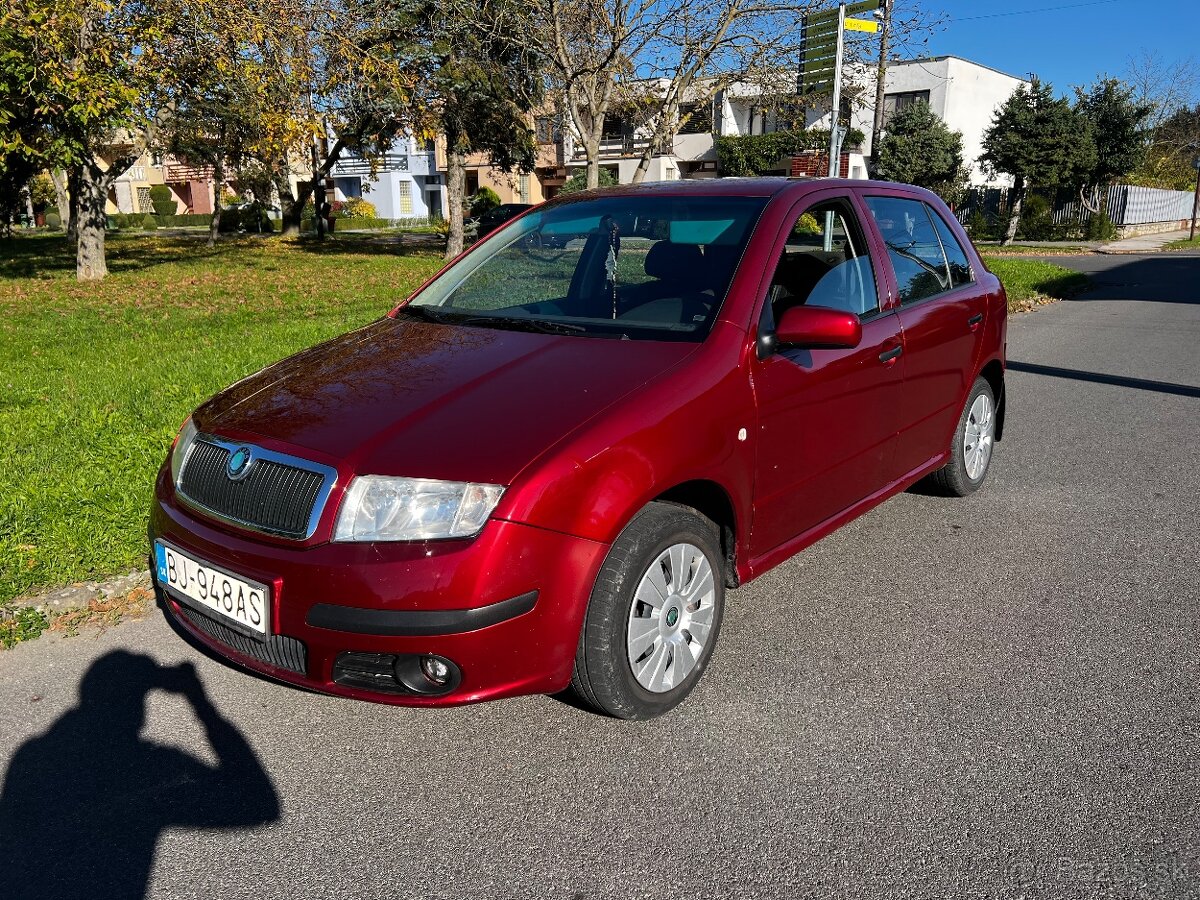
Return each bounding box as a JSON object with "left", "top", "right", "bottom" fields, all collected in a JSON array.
[{"left": 769, "top": 200, "right": 880, "bottom": 322}]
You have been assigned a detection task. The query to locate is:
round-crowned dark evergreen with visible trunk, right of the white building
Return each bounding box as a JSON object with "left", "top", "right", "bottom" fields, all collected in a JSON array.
[{"left": 980, "top": 78, "right": 1096, "bottom": 244}]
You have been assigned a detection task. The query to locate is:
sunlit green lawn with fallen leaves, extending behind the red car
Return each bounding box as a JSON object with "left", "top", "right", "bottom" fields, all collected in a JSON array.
[{"left": 0, "top": 234, "right": 1081, "bottom": 633}]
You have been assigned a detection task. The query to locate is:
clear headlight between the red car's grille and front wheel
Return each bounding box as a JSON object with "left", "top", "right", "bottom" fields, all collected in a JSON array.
[{"left": 334, "top": 475, "right": 504, "bottom": 541}]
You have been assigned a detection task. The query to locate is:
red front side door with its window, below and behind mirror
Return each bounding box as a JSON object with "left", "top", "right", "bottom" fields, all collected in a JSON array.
[{"left": 751, "top": 192, "right": 902, "bottom": 556}]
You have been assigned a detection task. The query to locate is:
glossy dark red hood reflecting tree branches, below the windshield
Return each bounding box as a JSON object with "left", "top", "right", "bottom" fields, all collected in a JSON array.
[{"left": 196, "top": 319, "right": 698, "bottom": 485}]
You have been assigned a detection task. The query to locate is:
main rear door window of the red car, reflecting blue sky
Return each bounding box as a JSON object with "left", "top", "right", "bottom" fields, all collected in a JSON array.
[{"left": 864, "top": 197, "right": 952, "bottom": 304}]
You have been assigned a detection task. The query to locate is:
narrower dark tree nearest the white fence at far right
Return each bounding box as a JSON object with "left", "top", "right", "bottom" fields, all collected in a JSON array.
[{"left": 1075, "top": 78, "right": 1154, "bottom": 215}]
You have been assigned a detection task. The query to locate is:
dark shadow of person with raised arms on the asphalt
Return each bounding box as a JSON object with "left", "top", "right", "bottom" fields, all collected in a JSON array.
[{"left": 0, "top": 650, "right": 280, "bottom": 900}]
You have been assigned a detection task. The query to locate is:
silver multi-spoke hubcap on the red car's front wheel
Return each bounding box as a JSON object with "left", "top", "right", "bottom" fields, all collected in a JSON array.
[{"left": 625, "top": 544, "right": 716, "bottom": 694}]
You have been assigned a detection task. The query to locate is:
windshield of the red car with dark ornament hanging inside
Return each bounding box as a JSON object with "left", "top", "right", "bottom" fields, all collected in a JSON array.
[{"left": 397, "top": 196, "right": 766, "bottom": 341}]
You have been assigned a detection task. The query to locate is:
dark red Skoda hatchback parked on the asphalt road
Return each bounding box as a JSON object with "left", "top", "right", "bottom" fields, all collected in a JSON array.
[{"left": 150, "top": 179, "right": 1007, "bottom": 719}]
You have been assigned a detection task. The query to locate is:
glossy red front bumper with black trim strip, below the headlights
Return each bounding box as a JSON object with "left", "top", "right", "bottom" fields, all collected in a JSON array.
[{"left": 149, "top": 472, "right": 607, "bottom": 706}]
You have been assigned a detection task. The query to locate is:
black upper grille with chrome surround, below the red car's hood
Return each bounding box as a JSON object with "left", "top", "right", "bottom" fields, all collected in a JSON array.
[{"left": 179, "top": 437, "right": 331, "bottom": 538}]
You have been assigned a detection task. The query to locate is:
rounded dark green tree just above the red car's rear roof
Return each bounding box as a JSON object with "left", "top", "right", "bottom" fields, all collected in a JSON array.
[{"left": 877, "top": 102, "right": 967, "bottom": 204}]
